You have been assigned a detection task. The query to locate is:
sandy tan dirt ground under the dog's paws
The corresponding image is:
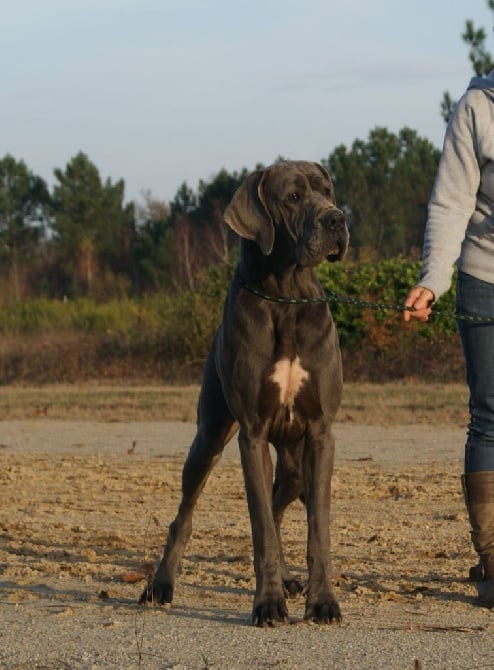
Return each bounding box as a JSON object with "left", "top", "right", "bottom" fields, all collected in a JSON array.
[{"left": 0, "top": 418, "right": 494, "bottom": 670}]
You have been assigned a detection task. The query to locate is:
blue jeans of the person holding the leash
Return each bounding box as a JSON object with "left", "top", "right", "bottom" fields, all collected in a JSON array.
[{"left": 456, "top": 272, "right": 494, "bottom": 473}]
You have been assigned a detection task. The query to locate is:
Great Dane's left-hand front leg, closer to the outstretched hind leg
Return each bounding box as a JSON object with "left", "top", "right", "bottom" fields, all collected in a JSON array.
[{"left": 239, "top": 430, "right": 288, "bottom": 626}]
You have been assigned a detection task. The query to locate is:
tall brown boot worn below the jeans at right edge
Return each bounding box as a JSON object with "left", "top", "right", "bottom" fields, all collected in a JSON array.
[{"left": 462, "top": 471, "right": 494, "bottom": 607}]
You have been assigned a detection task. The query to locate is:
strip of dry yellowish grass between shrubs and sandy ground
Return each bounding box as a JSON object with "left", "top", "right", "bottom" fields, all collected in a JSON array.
[{"left": 0, "top": 382, "right": 467, "bottom": 426}]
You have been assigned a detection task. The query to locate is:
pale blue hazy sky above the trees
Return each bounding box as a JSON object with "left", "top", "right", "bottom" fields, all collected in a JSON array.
[{"left": 0, "top": 0, "right": 494, "bottom": 202}]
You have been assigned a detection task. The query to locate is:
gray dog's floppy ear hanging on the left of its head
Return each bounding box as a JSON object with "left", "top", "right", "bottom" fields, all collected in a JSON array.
[{"left": 224, "top": 170, "right": 274, "bottom": 256}]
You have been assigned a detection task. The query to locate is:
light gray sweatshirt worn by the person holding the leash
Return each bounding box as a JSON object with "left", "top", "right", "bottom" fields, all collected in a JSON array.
[{"left": 418, "top": 70, "right": 494, "bottom": 300}]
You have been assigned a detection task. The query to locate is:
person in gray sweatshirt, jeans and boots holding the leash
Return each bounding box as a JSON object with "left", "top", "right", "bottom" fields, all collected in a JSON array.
[{"left": 403, "top": 70, "right": 494, "bottom": 607}]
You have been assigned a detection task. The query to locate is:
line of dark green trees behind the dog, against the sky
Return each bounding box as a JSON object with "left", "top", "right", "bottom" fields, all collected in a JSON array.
[{"left": 0, "top": 128, "right": 439, "bottom": 301}]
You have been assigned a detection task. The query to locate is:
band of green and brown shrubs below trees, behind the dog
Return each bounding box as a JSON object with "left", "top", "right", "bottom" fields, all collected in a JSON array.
[{"left": 0, "top": 258, "right": 463, "bottom": 383}]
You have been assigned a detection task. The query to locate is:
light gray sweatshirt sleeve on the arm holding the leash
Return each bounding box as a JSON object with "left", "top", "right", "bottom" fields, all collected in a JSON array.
[{"left": 419, "top": 91, "right": 483, "bottom": 300}]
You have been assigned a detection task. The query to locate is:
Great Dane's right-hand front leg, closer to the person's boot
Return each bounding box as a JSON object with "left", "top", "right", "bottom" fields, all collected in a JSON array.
[{"left": 304, "top": 435, "right": 341, "bottom": 623}]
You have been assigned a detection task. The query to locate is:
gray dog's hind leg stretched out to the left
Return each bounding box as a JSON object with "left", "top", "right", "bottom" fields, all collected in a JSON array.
[{"left": 140, "top": 354, "right": 238, "bottom": 605}]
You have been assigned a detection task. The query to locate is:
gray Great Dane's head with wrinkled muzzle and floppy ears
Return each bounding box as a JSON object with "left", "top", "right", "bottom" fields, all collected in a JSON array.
[{"left": 225, "top": 161, "right": 348, "bottom": 267}]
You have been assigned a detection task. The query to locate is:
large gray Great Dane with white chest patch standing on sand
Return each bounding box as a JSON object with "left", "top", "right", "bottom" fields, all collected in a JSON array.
[{"left": 141, "top": 161, "right": 348, "bottom": 626}]
